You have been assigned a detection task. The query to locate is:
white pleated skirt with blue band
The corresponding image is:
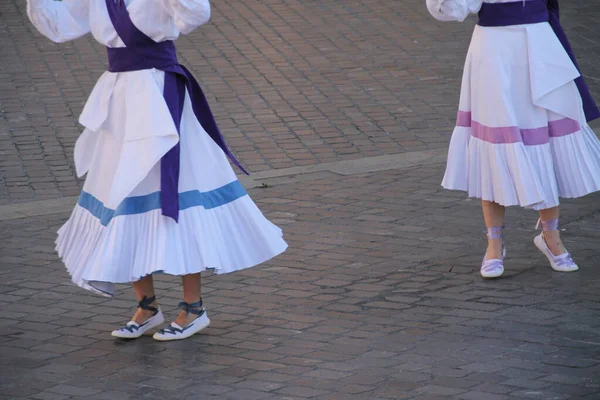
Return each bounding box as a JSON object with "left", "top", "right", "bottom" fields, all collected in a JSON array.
[{"left": 56, "top": 70, "right": 287, "bottom": 296}]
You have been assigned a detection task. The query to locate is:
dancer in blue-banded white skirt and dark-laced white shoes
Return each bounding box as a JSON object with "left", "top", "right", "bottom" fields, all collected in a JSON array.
[{"left": 27, "top": 0, "right": 287, "bottom": 340}]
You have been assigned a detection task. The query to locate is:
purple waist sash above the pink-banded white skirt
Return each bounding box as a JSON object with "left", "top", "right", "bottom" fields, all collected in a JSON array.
[{"left": 478, "top": 0, "right": 600, "bottom": 122}]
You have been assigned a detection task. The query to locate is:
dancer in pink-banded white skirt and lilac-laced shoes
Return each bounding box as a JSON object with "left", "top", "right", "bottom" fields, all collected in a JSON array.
[{"left": 426, "top": 0, "right": 600, "bottom": 278}]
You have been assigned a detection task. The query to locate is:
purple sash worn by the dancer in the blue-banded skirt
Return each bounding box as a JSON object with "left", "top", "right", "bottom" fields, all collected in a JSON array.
[{"left": 106, "top": 0, "right": 248, "bottom": 221}]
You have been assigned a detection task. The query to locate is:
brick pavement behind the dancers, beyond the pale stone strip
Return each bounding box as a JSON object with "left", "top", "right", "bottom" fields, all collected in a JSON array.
[{"left": 0, "top": 0, "right": 600, "bottom": 205}]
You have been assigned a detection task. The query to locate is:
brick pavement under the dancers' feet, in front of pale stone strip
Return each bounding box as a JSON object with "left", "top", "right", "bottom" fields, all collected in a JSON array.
[{"left": 0, "top": 164, "right": 600, "bottom": 400}]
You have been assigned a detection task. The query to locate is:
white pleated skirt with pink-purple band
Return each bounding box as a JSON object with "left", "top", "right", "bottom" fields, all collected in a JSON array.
[{"left": 442, "top": 23, "right": 600, "bottom": 210}]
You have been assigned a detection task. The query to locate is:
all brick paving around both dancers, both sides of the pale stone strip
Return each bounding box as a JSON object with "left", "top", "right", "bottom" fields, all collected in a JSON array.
[{"left": 0, "top": 0, "right": 600, "bottom": 400}]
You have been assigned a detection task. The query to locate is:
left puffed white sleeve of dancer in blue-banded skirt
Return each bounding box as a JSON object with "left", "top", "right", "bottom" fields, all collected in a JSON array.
[{"left": 27, "top": 0, "right": 90, "bottom": 43}]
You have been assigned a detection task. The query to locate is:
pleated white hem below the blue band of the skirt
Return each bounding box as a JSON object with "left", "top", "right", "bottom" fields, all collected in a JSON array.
[{"left": 56, "top": 195, "right": 287, "bottom": 296}]
